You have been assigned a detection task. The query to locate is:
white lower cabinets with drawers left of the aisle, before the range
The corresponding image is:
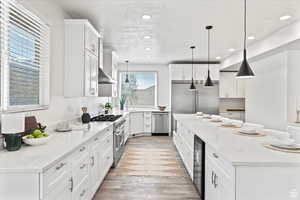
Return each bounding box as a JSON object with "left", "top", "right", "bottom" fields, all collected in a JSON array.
[{"left": 41, "top": 127, "right": 113, "bottom": 200}]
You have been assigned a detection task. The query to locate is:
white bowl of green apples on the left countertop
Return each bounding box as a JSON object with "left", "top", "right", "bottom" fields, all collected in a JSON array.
[{"left": 23, "top": 129, "right": 51, "bottom": 146}]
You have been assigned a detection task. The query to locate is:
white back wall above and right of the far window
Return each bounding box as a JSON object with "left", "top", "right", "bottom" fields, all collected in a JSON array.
[{"left": 118, "top": 64, "right": 170, "bottom": 106}]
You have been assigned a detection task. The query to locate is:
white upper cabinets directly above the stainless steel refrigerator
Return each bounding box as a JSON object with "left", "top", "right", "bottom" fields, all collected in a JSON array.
[{"left": 170, "top": 64, "right": 219, "bottom": 80}]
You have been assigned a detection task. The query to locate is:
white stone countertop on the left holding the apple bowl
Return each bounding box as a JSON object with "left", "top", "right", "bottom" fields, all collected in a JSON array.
[{"left": 0, "top": 122, "right": 113, "bottom": 173}]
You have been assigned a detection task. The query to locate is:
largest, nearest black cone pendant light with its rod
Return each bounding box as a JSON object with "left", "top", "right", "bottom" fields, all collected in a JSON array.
[{"left": 237, "top": 0, "right": 255, "bottom": 78}]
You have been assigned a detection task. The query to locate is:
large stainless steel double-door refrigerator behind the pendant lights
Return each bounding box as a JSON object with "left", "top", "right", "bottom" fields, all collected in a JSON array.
[{"left": 172, "top": 81, "right": 219, "bottom": 114}]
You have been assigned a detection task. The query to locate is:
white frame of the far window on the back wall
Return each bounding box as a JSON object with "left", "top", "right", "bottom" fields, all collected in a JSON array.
[{"left": 117, "top": 70, "right": 158, "bottom": 108}]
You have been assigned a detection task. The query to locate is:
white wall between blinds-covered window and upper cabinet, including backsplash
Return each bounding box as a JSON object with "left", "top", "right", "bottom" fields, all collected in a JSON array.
[{"left": 22, "top": 0, "right": 107, "bottom": 125}]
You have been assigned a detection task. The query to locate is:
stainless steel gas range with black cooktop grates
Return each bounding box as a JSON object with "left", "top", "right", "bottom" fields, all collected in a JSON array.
[{"left": 91, "top": 115, "right": 126, "bottom": 167}]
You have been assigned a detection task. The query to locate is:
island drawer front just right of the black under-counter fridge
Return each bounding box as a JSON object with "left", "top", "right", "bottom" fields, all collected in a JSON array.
[{"left": 206, "top": 145, "right": 235, "bottom": 177}]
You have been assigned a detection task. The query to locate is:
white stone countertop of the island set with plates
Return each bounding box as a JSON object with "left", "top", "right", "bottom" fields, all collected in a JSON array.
[{"left": 174, "top": 114, "right": 300, "bottom": 167}]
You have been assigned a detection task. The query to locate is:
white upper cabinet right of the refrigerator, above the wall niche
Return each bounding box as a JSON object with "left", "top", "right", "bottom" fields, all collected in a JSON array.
[{"left": 220, "top": 71, "right": 245, "bottom": 98}]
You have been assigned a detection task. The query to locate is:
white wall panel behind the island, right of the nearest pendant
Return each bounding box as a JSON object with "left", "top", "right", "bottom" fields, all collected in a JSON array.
[{"left": 246, "top": 52, "right": 287, "bottom": 130}]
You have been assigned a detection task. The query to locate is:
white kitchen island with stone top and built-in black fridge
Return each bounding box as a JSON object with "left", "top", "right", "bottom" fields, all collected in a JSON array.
[{"left": 173, "top": 114, "right": 300, "bottom": 200}]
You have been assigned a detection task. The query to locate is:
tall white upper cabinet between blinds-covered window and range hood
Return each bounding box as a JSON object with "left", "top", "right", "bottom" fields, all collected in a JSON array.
[{"left": 64, "top": 20, "right": 103, "bottom": 97}]
